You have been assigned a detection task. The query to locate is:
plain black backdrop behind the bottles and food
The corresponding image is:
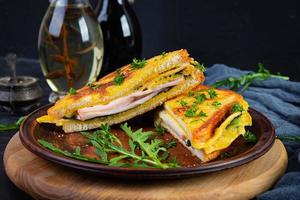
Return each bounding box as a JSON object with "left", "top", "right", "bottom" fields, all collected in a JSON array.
[{"left": 0, "top": 0, "right": 300, "bottom": 81}]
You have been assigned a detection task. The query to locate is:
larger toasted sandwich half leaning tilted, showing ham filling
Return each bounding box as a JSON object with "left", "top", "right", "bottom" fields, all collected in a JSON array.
[{"left": 37, "top": 49, "right": 204, "bottom": 132}]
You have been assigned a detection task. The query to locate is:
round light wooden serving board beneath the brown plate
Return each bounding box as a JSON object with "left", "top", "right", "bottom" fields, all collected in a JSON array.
[{"left": 4, "top": 134, "right": 287, "bottom": 200}]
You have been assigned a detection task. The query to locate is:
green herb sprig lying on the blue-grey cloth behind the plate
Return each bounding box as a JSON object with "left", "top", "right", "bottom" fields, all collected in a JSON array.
[{"left": 213, "top": 63, "right": 289, "bottom": 91}]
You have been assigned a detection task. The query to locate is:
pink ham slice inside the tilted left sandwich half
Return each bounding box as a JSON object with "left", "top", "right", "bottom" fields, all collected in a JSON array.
[{"left": 77, "top": 78, "right": 183, "bottom": 121}]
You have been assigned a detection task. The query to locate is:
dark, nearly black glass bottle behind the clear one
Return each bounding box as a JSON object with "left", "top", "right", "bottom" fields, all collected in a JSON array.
[{"left": 95, "top": 0, "right": 142, "bottom": 75}]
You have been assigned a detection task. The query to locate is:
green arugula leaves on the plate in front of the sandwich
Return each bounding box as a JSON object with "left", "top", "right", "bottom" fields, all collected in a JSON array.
[{"left": 38, "top": 123, "right": 179, "bottom": 169}]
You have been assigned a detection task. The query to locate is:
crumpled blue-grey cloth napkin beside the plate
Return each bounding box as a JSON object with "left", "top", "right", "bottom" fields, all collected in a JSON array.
[{"left": 205, "top": 64, "right": 300, "bottom": 200}]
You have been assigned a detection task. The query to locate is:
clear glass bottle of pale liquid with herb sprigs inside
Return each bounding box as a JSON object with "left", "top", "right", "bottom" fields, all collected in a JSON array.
[{"left": 38, "top": 0, "right": 103, "bottom": 102}]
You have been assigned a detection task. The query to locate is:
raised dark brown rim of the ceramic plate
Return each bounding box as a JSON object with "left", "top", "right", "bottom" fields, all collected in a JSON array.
[{"left": 19, "top": 104, "right": 275, "bottom": 179}]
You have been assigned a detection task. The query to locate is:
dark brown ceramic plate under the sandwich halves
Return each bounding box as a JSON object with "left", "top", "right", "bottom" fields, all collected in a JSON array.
[{"left": 20, "top": 105, "right": 275, "bottom": 179}]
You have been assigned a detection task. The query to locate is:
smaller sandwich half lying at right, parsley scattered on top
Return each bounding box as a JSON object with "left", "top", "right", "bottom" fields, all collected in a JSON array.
[{"left": 155, "top": 85, "right": 252, "bottom": 162}]
